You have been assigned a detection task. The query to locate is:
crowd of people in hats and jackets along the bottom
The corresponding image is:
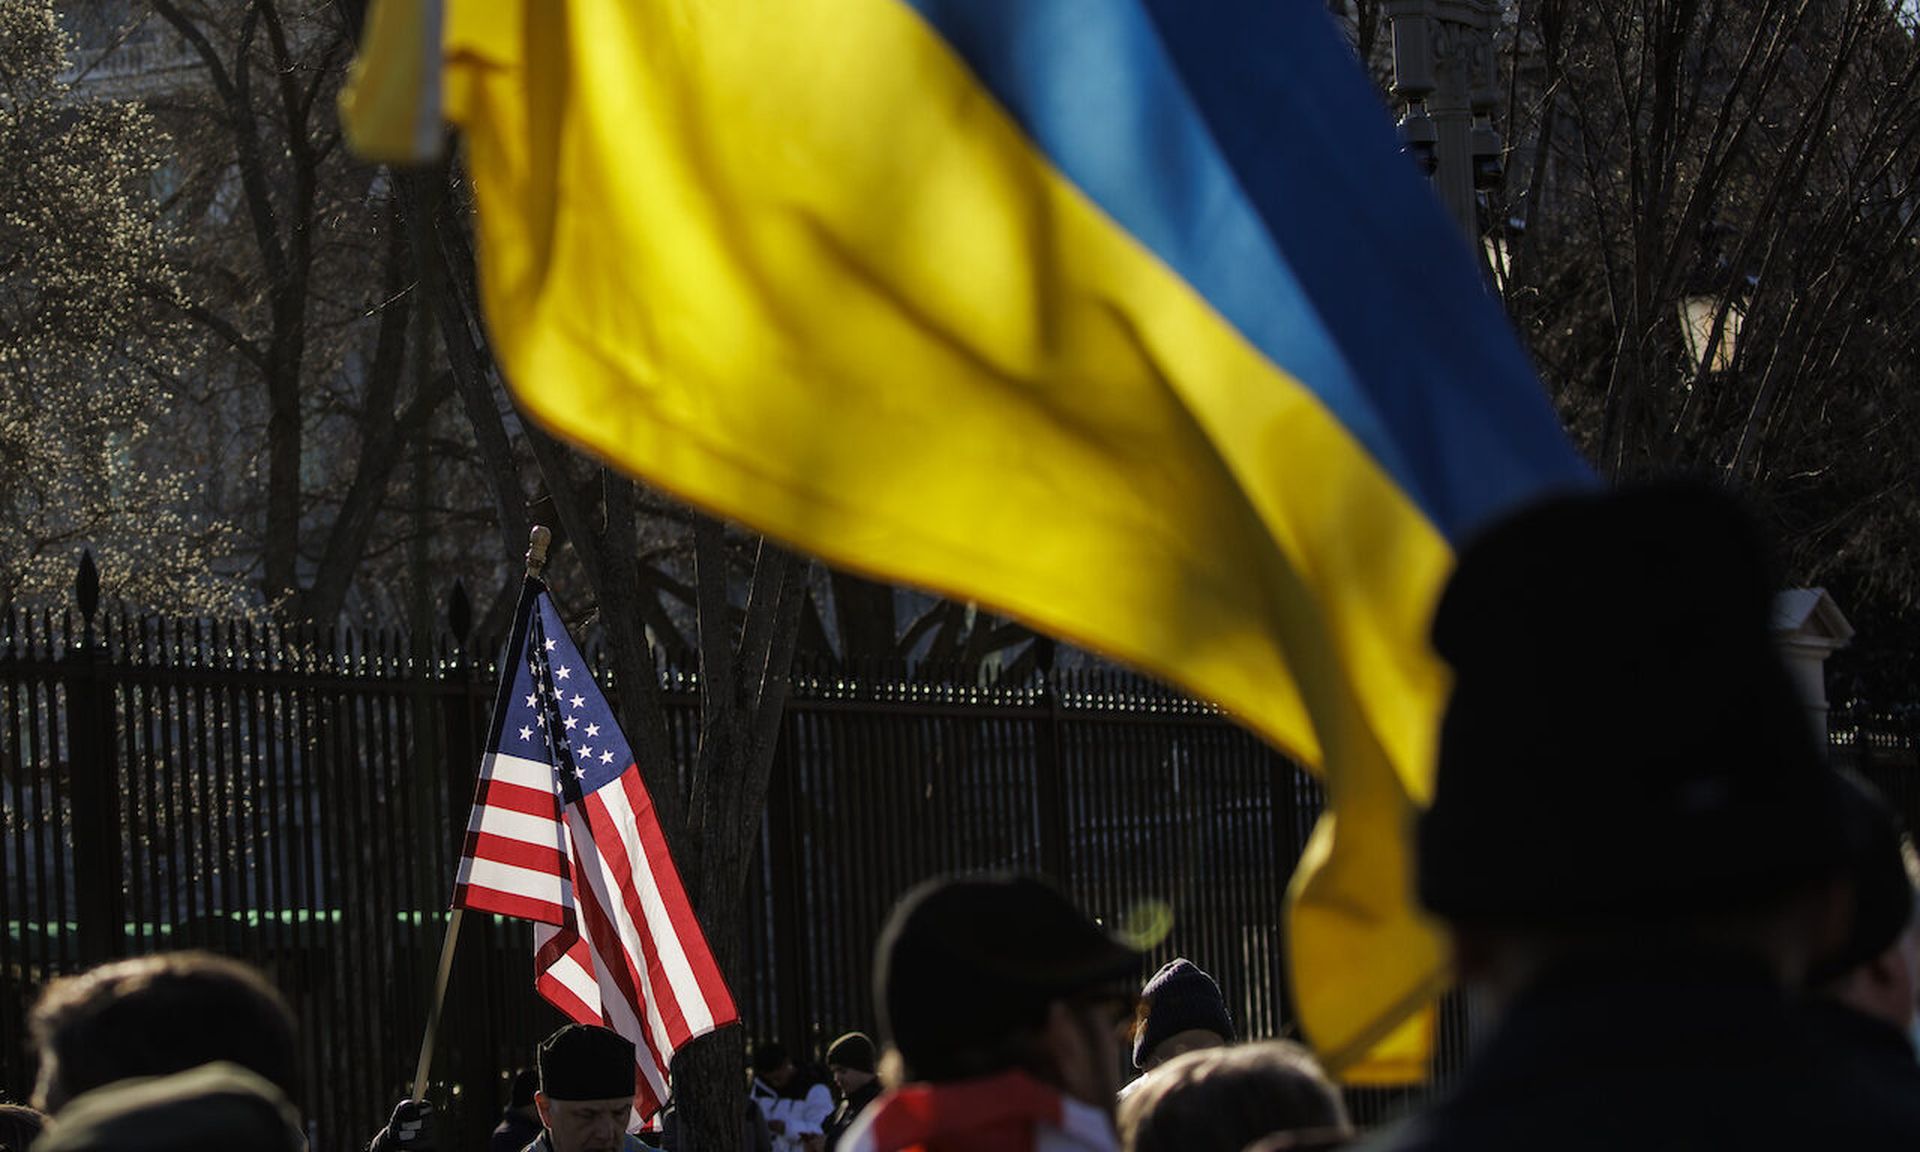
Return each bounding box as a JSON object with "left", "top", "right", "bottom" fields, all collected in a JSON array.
[{"left": 0, "top": 488, "right": 1920, "bottom": 1152}]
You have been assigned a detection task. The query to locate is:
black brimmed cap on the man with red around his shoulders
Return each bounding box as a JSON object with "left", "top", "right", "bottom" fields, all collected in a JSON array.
[{"left": 874, "top": 876, "right": 1140, "bottom": 1081}]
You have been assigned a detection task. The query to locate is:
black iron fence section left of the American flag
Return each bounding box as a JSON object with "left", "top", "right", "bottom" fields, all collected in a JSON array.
[{"left": 0, "top": 611, "right": 528, "bottom": 1148}]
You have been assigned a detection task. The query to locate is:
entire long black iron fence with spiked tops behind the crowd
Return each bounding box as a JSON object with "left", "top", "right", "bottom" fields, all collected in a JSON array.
[{"left": 0, "top": 568, "right": 1920, "bottom": 1152}]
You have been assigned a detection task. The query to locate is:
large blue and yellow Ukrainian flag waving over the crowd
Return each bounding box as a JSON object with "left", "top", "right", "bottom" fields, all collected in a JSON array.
[{"left": 346, "top": 0, "right": 1588, "bottom": 1073}]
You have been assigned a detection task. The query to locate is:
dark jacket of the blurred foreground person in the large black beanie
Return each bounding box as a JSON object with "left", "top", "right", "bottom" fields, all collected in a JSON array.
[{"left": 1365, "top": 956, "right": 1920, "bottom": 1152}]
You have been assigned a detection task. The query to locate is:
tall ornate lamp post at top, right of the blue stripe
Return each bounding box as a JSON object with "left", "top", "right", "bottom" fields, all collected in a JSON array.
[{"left": 1386, "top": 0, "right": 1501, "bottom": 242}]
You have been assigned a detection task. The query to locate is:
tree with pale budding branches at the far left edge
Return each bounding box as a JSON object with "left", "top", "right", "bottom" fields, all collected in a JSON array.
[{"left": 0, "top": 0, "right": 236, "bottom": 611}]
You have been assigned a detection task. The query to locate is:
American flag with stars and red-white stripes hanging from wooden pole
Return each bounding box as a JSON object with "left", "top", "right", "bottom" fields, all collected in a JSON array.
[{"left": 453, "top": 580, "right": 739, "bottom": 1117}]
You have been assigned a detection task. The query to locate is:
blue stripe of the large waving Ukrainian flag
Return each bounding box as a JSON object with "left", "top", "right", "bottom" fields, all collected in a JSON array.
[{"left": 904, "top": 0, "right": 1590, "bottom": 541}]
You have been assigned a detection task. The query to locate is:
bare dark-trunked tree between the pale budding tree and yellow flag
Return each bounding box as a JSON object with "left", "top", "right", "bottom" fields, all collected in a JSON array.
[{"left": 134, "top": 0, "right": 513, "bottom": 624}]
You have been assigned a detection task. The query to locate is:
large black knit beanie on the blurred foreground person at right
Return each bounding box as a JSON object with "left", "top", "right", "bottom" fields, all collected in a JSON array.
[{"left": 1417, "top": 486, "right": 1843, "bottom": 927}]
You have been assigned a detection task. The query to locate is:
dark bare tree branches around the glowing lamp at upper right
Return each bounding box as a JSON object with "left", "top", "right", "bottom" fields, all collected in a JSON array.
[{"left": 1488, "top": 0, "right": 1920, "bottom": 603}]
